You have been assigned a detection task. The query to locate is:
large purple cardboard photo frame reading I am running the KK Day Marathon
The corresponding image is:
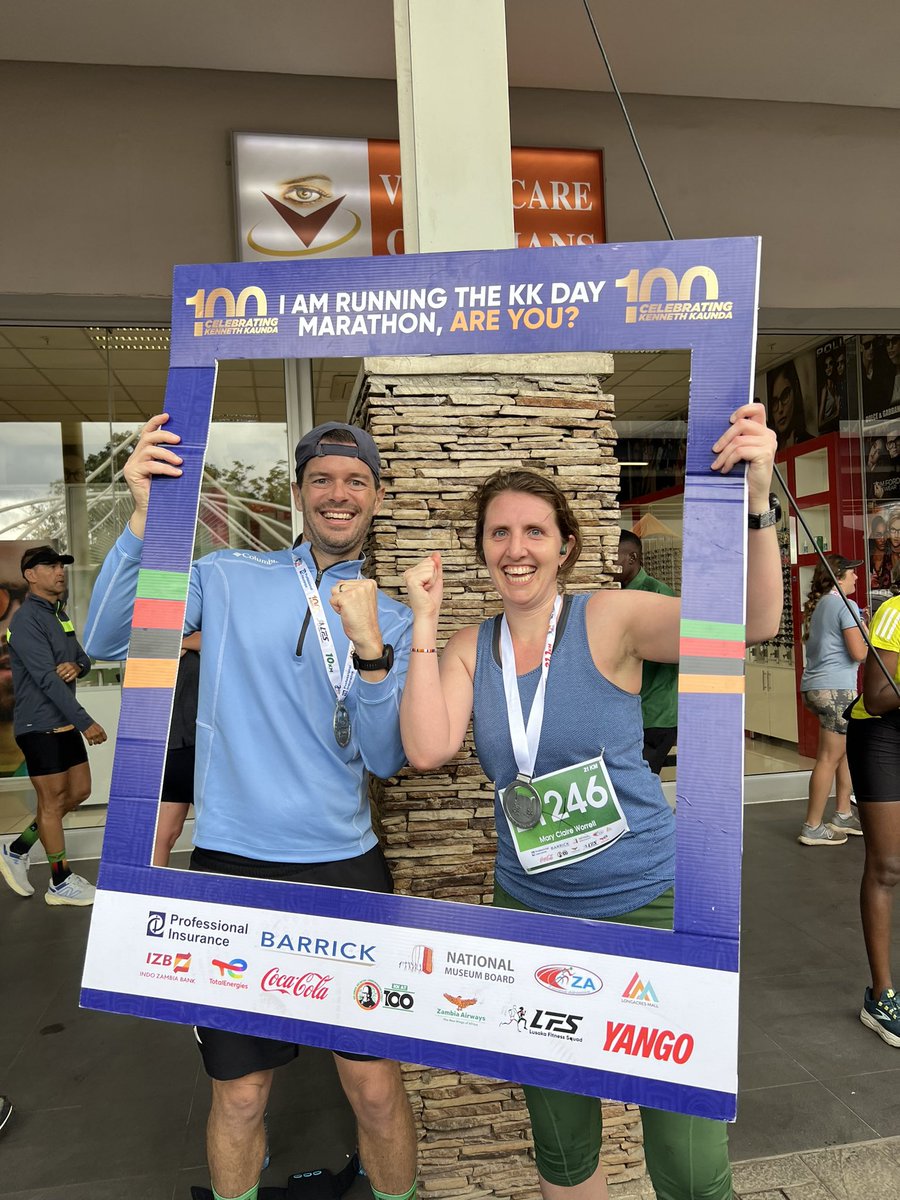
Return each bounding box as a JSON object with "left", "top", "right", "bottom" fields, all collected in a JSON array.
[{"left": 82, "top": 239, "right": 760, "bottom": 1120}]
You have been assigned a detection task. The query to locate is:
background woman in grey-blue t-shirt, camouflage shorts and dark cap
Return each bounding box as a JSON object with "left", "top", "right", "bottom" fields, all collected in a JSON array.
[{"left": 797, "top": 554, "right": 865, "bottom": 846}]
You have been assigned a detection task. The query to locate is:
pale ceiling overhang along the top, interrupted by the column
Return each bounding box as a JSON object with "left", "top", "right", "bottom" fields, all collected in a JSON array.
[{"left": 7, "top": 0, "right": 900, "bottom": 108}]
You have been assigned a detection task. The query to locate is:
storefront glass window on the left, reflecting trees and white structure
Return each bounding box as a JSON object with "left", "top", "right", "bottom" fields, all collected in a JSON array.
[{"left": 0, "top": 326, "right": 285, "bottom": 787}]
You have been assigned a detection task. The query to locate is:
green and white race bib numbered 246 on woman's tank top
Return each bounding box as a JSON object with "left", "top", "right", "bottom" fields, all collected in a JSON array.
[{"left": 506, "top": 751, "right": 628, "bottom": 875}]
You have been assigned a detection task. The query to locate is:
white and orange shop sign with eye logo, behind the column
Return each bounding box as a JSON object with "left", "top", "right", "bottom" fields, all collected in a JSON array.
[{"left": 236, "top": 133, "right": 606, "bottom": 264}]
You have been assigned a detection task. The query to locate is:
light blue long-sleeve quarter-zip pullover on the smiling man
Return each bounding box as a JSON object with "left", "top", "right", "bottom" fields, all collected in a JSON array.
[{"left": 85, "top": 528, "right": 413, "bottom": 863}]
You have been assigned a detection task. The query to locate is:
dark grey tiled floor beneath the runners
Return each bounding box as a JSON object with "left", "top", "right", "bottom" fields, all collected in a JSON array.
[{"left": 0, "top": 802, "right": 900, "bottom": 1200}]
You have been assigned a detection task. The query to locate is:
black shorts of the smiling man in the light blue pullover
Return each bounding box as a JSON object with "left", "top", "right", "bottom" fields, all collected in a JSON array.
[{"left": 191, "top": 846, "right": 394, "bottom": 1080}]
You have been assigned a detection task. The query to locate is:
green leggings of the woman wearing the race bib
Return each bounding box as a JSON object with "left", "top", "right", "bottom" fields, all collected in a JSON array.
[{"left": 493, "top": 883, "right": 732, "bottom": 1200}]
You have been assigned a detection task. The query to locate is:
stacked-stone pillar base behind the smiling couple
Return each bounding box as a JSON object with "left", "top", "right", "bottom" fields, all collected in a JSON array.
[{"left": 352, "top": 354, "right": 644, "bottom": 1200}]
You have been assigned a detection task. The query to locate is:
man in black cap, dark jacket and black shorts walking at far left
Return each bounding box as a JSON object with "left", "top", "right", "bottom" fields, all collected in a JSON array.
[{"left": 0, "top": 546, "right": 107, "bottom": 907}]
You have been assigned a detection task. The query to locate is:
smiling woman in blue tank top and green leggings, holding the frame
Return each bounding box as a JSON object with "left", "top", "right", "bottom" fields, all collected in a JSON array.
[{"left": 401, "top": 404, "right": 781, "bottom": 1200}]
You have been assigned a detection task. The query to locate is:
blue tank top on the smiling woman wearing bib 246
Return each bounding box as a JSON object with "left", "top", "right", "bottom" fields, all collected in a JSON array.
[{"left": 473, "top": 594, "right": 674, "bottom": 918}]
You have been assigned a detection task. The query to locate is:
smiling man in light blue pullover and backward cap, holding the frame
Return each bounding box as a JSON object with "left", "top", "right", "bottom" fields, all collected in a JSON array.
[{"left": 86, "top": 414, "right": 416, "bottom": 1200}]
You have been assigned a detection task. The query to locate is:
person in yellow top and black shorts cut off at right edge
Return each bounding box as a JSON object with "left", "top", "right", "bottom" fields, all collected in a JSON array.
[{"left": 847, "top": 596, "right": 900, "bottom": 1046}]
